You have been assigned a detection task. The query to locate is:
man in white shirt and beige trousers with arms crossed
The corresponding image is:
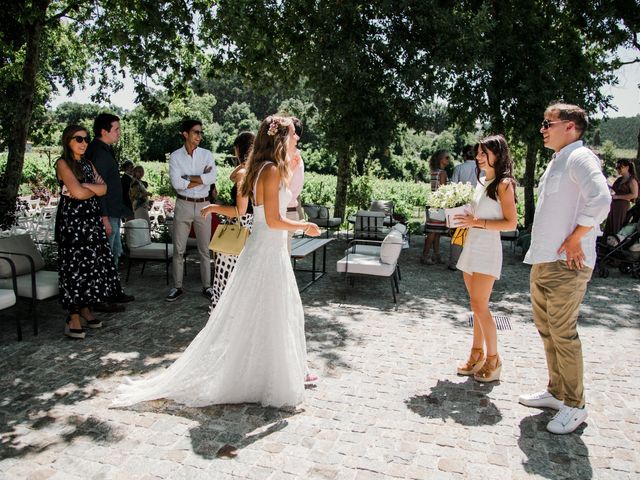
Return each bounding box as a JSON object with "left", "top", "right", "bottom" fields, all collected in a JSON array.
[{"left": 165, "top": 120, "right": 216, "bottom": 302}]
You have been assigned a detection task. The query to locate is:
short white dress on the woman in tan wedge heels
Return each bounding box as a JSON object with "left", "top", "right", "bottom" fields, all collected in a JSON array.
[{"left": 456, "top": 178, "right": 504, "bottom": 280}]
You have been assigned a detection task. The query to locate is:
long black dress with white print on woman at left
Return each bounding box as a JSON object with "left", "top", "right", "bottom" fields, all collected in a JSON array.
[{"left": 55, "top": 159, "right": 123, "bottom": 313}]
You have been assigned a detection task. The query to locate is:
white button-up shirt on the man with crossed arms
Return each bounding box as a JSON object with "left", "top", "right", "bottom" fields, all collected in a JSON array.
[{"left": 169, "top": 146, "right": 216, "bottom": 198}]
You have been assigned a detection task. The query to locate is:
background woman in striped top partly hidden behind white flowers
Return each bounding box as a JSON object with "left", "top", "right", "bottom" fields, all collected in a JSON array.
[{"left": 420, "top": 150, "right": 450, "bottom": 265}]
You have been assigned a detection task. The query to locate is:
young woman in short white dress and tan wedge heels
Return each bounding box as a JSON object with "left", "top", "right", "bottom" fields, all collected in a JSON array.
[{"left": 456, "top": 135, "right": 518, "bottom": 382}]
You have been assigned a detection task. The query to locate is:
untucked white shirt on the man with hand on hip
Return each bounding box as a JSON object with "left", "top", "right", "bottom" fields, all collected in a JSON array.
[{"left": 524, "top": 140, "right": 611, "bottom": 268}]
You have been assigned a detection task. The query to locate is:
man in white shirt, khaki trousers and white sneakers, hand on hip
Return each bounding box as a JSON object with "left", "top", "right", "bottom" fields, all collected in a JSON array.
[{"left": 519, "top": 103, "right": 611, "bottom": 434}]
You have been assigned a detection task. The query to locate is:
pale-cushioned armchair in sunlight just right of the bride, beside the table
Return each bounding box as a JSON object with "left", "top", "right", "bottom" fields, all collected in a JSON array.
[{"left": 336, "top": 230, "right": 403, "bottom": 303}]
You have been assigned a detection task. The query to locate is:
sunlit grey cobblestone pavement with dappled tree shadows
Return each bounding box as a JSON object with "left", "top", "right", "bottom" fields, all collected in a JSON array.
[{"left": 0, "top": 237, "right": 640, "bottom": 480}]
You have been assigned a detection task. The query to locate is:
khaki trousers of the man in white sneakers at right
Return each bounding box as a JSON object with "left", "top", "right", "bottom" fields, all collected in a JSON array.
[{"left": 530, "top": 260, "right": 593, "bottom": 408}]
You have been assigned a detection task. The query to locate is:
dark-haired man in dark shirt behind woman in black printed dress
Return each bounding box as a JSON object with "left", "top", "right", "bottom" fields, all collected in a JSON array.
[{"left": 85, "top": 113, "right": 133, "bottom": 303}]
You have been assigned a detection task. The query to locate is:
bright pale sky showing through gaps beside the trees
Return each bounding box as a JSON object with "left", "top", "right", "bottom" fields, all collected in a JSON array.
[{"left": 51, "top": 50, "right": 640, "bottom": 117}]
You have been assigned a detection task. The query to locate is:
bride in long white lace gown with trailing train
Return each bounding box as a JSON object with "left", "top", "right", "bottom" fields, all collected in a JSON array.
[{"left": 114, "top": 115, "right": 320, "bottom": 408}]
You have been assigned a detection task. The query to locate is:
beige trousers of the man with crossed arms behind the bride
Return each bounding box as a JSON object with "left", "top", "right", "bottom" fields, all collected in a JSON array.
[{"left": 173, "top": 198, "right": 211, "bottom": 288}]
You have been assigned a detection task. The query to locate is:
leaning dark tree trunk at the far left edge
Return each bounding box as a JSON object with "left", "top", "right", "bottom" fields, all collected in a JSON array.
[{"left": 0, "top": 0, "right": 50, "bottom": 228}]
